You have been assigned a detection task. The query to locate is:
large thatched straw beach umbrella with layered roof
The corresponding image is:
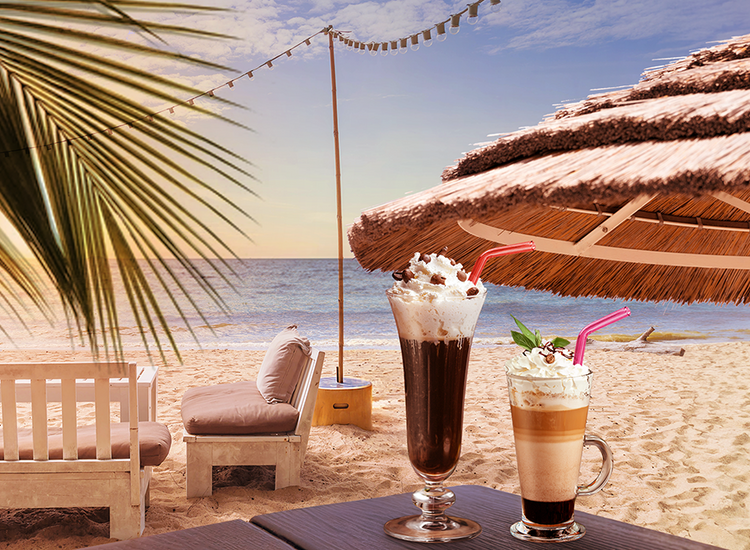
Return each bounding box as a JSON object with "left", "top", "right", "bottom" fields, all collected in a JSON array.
[{"left": 349, "top": 35, "right": 750, "bottom": 303}]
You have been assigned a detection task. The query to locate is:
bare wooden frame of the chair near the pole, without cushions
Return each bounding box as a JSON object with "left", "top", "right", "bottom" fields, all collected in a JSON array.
[{"left": 182, "top": 350, "right": 325, "bottom": 498}]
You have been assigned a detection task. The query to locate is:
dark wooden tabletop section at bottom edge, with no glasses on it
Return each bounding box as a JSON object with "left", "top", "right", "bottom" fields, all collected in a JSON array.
[{"left": 81, "top": 519, "right": 294, "bottom": 550}]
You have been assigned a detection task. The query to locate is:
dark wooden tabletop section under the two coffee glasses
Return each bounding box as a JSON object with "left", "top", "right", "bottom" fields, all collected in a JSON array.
[{"left": 251, "top": 485, "right": 728, "bottom": 550}]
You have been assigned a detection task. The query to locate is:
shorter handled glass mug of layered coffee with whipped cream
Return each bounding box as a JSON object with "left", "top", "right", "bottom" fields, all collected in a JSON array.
[{"left": 506, "top": 326, "right": 612, "bottom": 542}]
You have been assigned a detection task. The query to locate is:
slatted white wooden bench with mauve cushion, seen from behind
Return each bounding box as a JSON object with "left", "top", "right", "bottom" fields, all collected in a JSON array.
[{"left": 0, "top": 362, "right": 172, "bottom": 539}]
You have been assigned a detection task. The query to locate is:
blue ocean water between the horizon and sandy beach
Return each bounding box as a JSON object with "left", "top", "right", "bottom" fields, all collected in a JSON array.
[{"left": 0, "top": 259, "right": 750, "bottom": 350}]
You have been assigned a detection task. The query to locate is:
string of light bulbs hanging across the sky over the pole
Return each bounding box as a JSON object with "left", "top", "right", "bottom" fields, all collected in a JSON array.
[{"left": 4, "top": 0, "right": 501, "bottom": 157}]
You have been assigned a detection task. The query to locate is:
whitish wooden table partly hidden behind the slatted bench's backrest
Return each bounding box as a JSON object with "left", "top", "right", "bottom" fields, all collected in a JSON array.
[{"left": 16, "top": 366, "right": 159, "bottom": 422}]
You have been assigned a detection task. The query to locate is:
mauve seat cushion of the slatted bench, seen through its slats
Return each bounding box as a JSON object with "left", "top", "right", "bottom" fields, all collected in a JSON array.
[{"left": 0, "top": 422, "right": 172, "bottom": 467}]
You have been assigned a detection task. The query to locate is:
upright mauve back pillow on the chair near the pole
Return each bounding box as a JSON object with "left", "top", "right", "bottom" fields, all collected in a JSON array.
[{"left": 256, "top": 325, "right": 312, "bottom": 403}]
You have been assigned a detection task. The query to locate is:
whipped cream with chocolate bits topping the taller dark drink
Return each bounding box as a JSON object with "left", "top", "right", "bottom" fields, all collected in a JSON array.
[{"left": 386, "top": 252, "right": 487, "bottom": 342}]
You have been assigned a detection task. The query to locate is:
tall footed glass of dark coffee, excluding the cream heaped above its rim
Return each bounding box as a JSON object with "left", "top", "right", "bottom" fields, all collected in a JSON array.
[{"left": 385, "top": 289, "right": 486, "bottom": 542}]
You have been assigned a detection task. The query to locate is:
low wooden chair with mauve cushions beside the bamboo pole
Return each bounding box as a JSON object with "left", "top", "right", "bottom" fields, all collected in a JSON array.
[{"left": 182, "top": 327, "right": 325, "bottom": 498}]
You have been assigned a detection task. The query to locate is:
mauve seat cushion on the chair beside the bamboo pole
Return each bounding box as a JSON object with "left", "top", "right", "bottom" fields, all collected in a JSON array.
[{"left": 182, "top": 380, "right": 299, "bottom": 435}]
